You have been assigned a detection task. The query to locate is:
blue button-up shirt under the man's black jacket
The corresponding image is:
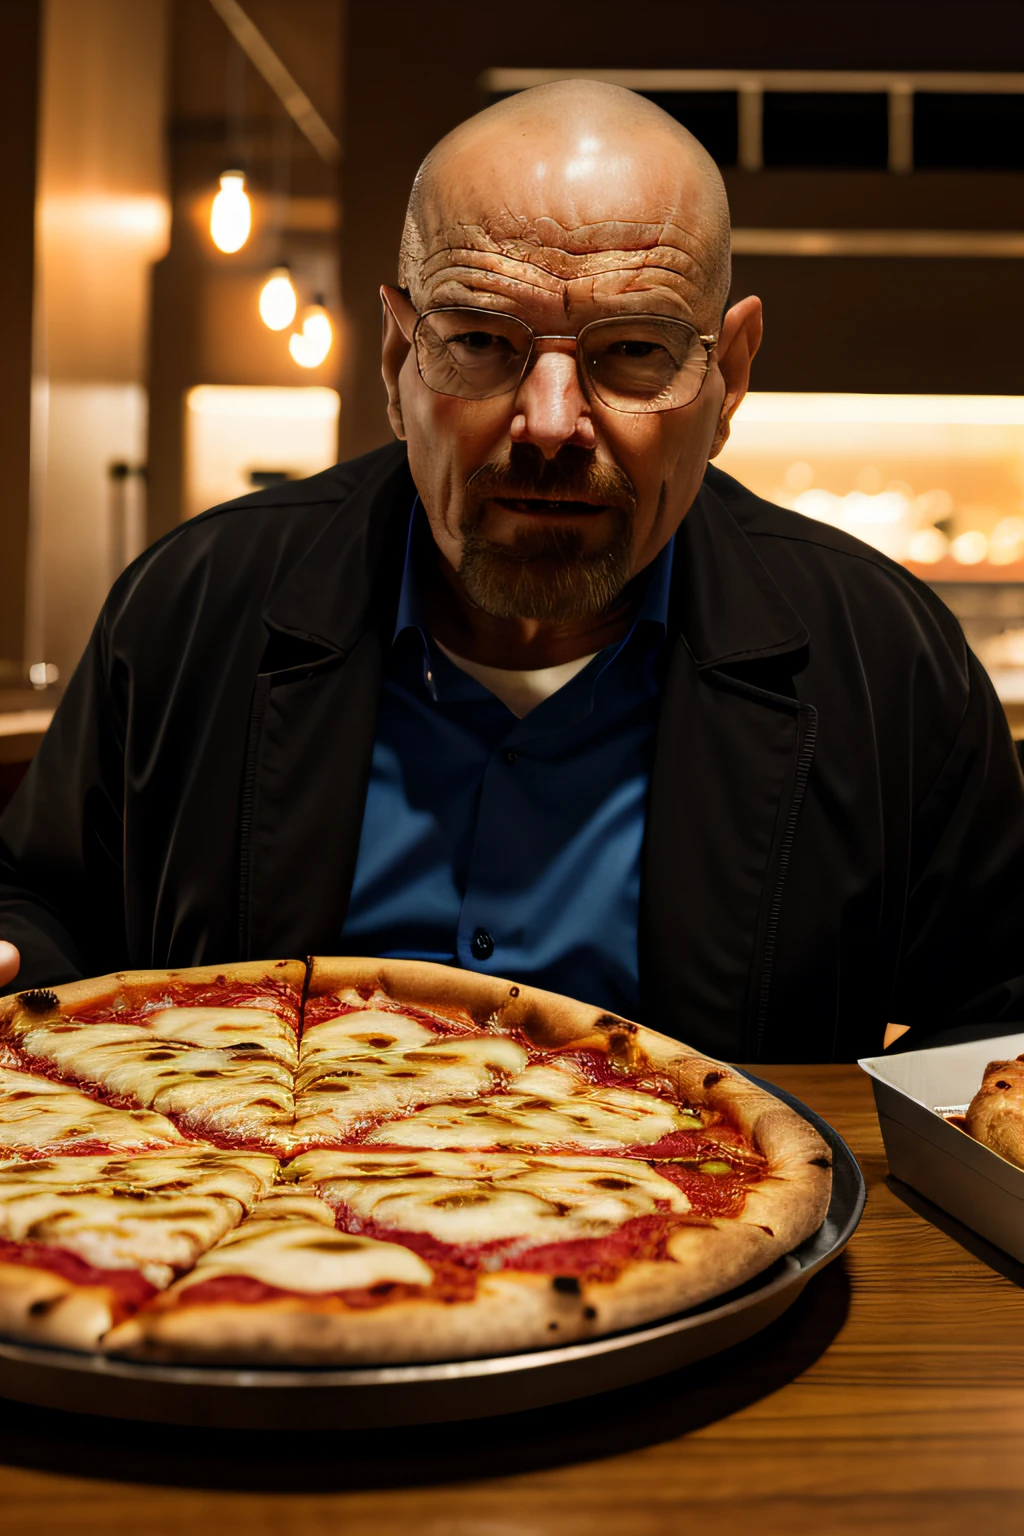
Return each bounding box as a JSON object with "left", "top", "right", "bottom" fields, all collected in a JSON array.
[{"left": 341, "top": 510, "right": 672, "bottom": 1017}]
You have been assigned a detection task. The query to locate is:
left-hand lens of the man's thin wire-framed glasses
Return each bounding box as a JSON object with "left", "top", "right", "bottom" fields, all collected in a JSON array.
[{"left": 416, "top": 309, "right": 533, "bottom": 399}]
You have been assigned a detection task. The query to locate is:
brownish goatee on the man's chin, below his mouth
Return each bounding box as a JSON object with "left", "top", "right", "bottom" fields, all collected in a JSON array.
[{"left": 459, "top": 510, "right": 633, "bottom": 624}]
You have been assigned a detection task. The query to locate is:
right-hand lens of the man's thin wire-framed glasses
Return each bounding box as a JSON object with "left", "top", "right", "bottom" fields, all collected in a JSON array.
[{"left": 580, "top": 315, "right": 708, "bottom": 412}]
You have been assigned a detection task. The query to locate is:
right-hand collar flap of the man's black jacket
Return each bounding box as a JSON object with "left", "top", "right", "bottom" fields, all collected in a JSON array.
[{"left": 671, "top": 467, "right": 811, "bottom": 670}]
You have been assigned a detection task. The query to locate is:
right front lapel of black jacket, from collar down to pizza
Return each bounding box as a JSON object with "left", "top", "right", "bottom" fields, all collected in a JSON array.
[{"left": 640, "top": 484, "right": 814, "bottom": 1060}]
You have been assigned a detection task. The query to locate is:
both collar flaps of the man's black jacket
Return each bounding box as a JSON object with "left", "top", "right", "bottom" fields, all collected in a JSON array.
[{"left": 264, "top": 442, "right": 809, "bottom": 670}]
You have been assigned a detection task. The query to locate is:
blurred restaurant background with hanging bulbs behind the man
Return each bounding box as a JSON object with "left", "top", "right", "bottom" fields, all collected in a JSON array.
[{"left": 0, "top": 0, "right": 1024, "bottom": 805}]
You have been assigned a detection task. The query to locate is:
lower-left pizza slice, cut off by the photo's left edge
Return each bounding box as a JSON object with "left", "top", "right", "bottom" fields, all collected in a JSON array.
[{"left": 0, "top": 1147, "right": 278, "bottom": 1349}]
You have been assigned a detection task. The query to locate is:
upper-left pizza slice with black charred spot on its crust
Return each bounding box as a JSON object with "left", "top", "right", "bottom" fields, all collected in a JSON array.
[{"left": 0, "top": 962, "right": 306, "bottom": 1149}]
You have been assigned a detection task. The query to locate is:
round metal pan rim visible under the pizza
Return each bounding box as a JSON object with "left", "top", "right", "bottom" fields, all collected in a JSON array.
[{"left": 0, "top": 1074, "right": 864, "bottom": 1430}]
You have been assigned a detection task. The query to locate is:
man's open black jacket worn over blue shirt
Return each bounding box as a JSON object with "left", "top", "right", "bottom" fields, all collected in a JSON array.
[{"left": 0, "top": 445, "right": 1024, "bottom": 1061}]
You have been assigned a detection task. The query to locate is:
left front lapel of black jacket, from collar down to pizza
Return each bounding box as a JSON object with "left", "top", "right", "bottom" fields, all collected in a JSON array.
[{"left": 239, "top": 450, "right": 415, "bottom": 955}]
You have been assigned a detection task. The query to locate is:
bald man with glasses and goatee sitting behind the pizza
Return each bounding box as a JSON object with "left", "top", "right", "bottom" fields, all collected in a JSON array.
[{"left": 0, "top": 81, "right": 1024, "bottom": 1061}]
